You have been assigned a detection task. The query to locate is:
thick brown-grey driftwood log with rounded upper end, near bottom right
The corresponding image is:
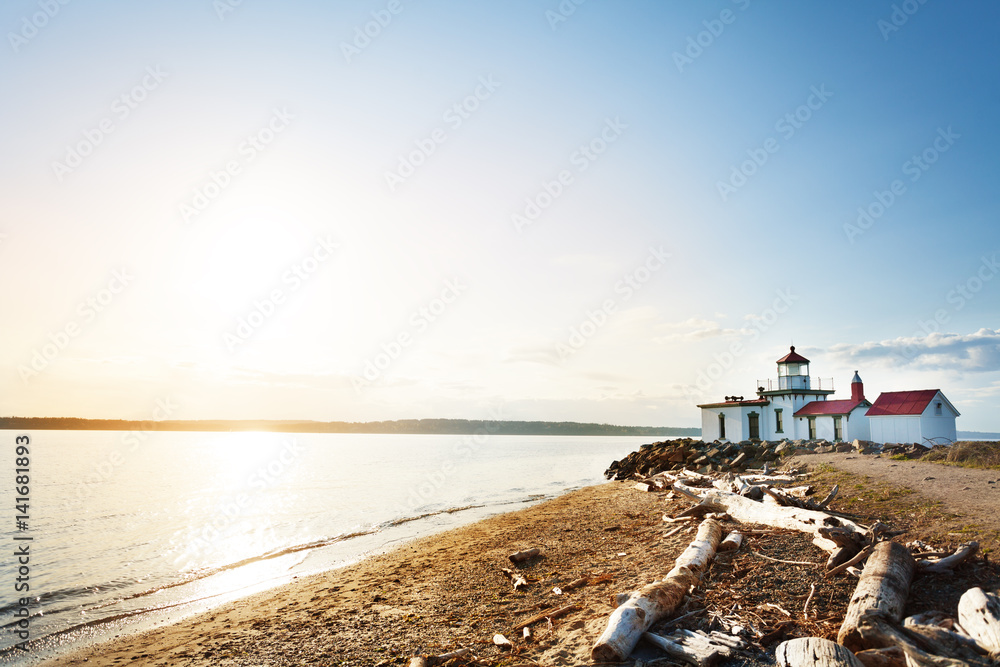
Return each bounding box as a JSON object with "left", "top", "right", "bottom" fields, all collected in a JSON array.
[{"left": 837, "top": 542, "right": 913, "bottom": 651}]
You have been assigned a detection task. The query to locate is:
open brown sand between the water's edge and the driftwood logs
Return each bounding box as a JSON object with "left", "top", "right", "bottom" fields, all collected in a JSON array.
[{"left": 39, "top": 482, "right": 663, "bottom": 667}]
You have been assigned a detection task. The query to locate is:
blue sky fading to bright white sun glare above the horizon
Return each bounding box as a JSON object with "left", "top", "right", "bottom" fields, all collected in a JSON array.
[{"left": 0, "top": 0, "right": 1000, "bottom": 430}]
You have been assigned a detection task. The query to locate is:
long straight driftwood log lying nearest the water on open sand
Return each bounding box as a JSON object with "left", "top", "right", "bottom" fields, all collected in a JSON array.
[{"left": 591, "top": 519, "right": 722, "bottom": 662}]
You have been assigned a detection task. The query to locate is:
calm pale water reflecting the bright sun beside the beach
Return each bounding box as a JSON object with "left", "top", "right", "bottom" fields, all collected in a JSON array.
[{"left": 0, "top": 431, "right": 652, "bottom": 664}]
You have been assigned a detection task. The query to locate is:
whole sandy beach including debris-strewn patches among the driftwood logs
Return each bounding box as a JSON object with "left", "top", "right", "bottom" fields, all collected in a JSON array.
[{"left": 35, "top": 460, "right": 998, "bottom": 667}]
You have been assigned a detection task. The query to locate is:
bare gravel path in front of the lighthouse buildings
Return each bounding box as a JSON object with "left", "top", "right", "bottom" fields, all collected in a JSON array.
[{"left": 790, "top": 454, "right": 1000, "bottom": 530}]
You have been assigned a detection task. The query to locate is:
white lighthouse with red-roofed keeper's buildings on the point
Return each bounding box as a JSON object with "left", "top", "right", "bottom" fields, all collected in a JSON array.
[{"left": 698, "top": 345, "right": 960, "bottom": 445}]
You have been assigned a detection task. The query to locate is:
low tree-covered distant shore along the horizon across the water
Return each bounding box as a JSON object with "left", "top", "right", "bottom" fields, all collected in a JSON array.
[{"left": 0, "top": 417, "right": 701, "bottom": 438}]
